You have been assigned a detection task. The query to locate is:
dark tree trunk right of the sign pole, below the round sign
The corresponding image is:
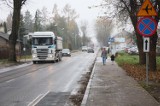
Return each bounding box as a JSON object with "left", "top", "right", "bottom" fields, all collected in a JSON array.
[{"left": 149, "top": 33, "right": 158, "bottom": 71}]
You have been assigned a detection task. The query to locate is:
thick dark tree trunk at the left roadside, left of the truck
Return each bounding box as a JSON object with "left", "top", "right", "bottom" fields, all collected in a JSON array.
[{"left": 9, "top": 0, "right": 22, "bottom": 62}]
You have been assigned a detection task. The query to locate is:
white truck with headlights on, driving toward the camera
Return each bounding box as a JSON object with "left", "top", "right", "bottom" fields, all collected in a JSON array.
[{"left": 32, "top": 32, "right": 63, "bottom": 64}]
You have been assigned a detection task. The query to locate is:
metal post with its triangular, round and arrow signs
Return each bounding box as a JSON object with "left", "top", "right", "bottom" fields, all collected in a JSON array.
[{"left": 137, "top": 0, "right": 157, "bottom": 86}]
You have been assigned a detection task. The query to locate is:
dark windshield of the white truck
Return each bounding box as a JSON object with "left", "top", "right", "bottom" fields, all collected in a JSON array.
[{"left": 32, "top": 37, "right": 53, "bottom": 45}]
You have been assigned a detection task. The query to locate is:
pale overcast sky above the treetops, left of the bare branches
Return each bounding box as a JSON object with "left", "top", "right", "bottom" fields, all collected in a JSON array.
[{"left": 0, "top": 0, "right": 104, "bottom": 41}]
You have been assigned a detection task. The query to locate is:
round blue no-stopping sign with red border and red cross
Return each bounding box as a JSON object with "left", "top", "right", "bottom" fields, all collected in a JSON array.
[{"left": 137, "top": 17, "right": 157, "bottom": 37}]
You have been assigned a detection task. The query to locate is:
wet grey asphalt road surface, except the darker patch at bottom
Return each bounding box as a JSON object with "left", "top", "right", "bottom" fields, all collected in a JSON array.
[{"left": 0, "top": 52, "right": 96, "bottom": 106}]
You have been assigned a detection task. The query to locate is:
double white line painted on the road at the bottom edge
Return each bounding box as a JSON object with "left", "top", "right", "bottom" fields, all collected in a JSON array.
[{"left": 27, "top": 91, "right": 49, "bottom": 106}]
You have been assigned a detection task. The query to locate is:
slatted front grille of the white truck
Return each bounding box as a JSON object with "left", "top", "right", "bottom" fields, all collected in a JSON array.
[{"left": 37, "top": 49, "right": 48, "bottom": 60}]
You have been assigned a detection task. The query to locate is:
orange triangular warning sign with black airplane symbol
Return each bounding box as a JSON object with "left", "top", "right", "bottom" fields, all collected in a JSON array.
[{"left": 137, "top": 0, "right": 157, "bottom": 17}]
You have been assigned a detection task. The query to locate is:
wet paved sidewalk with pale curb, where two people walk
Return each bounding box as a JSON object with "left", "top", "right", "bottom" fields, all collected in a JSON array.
[{"left": 81, "top": 54, "right": 160, "bottom": 106}]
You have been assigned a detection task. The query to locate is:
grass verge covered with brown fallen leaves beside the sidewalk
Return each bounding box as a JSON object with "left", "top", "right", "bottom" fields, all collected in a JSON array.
[{"left": 115, "top": 53, "right": 160, "bottom": 102}]
